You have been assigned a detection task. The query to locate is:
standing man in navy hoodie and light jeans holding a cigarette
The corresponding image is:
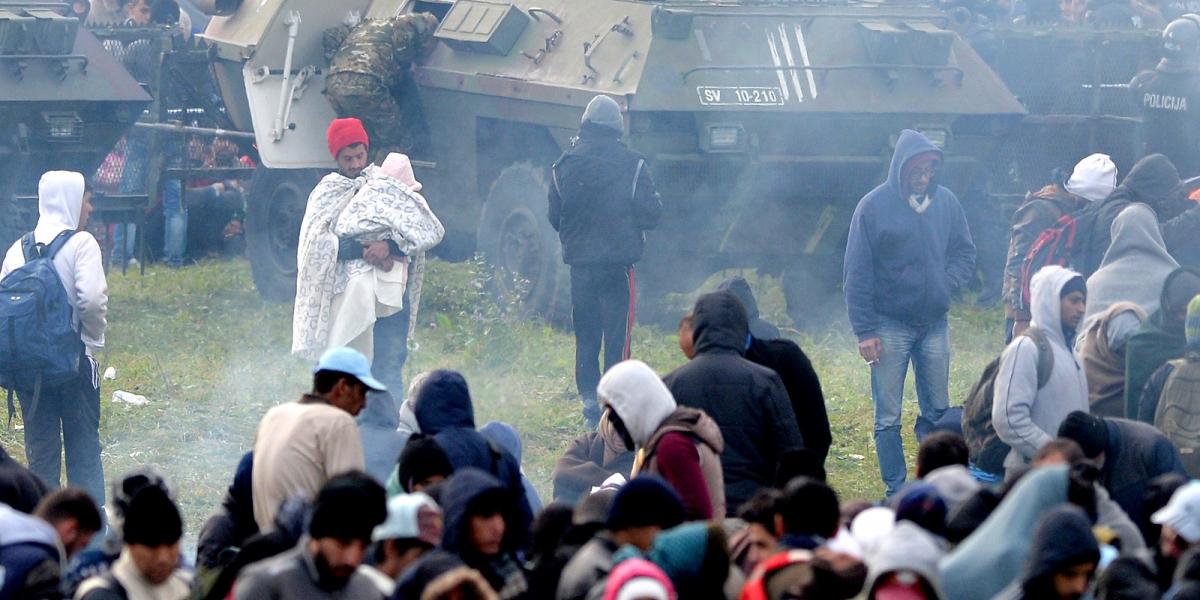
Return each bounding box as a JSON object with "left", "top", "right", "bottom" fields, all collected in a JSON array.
[{"left": 844, "top": 130, "right": 974, "bottom": 497}]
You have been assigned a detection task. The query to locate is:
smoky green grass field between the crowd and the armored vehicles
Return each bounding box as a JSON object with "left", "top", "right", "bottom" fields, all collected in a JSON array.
[{"left": 0, "top": 260, "right": 1002, "bottom": 539}]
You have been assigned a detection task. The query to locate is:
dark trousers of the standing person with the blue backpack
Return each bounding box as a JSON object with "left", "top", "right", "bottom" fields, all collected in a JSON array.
[{"left": 17, "top": 358, "right": 104, "bottom": 506}]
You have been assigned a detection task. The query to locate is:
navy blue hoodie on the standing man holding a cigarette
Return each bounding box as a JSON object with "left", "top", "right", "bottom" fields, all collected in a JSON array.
[{"left": 844, "top": 130, "right": 974, "bottom": 341}]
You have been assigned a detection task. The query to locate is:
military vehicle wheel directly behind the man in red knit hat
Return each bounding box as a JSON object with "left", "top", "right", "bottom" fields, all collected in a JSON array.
[{"left": 246, "top": 167, "right": 320, "bottom": 302}]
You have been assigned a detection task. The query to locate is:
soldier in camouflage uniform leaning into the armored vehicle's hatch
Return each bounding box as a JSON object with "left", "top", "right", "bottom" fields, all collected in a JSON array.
[{"left": 325, "top": 13, "right": 438, "bottom": 163}]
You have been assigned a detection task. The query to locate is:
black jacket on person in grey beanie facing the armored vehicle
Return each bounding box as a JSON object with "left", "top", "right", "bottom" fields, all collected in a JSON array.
[{"left": 548, "top": 125, "right": 662, "bottom": 265}]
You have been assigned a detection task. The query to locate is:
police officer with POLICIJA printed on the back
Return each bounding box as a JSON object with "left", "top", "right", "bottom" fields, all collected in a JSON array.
[{"left": 1129, "top": 14, "right": 1200, "bottom": 179}]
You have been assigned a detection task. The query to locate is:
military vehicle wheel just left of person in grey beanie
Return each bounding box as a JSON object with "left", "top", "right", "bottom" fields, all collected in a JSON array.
[{"left": 478, "top": 163, "right": 570, "bottom": 325}]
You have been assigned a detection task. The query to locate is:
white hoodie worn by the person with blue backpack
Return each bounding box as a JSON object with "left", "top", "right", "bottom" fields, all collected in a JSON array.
[{"left": 0, "top": 170, "right": 108, "bottom": 356}]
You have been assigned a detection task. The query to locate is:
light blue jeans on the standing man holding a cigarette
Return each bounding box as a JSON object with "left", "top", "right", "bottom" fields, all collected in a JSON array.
[{"left": 871, "top": 318, "right": 950, "bottom": 497}]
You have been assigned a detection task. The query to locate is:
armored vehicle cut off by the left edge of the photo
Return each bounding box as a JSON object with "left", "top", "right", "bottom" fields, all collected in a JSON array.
[{"left": 0, "top": 1, "right": 150, "bottom": 247}]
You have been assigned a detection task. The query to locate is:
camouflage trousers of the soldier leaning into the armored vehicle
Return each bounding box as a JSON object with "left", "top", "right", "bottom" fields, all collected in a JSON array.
[{"left": 325, "top": 73, "right": 421, "bottom": 164}]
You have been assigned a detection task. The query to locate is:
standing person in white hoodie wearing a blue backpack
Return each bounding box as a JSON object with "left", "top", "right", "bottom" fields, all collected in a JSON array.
[{"left": 0, "top": 170, "right": 108, "bottom": 505}]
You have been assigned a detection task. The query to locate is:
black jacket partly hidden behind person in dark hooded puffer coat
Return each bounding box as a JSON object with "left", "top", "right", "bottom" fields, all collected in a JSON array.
[{"left": 746, "top": 337, "right": 833, "bottom": 464}]
